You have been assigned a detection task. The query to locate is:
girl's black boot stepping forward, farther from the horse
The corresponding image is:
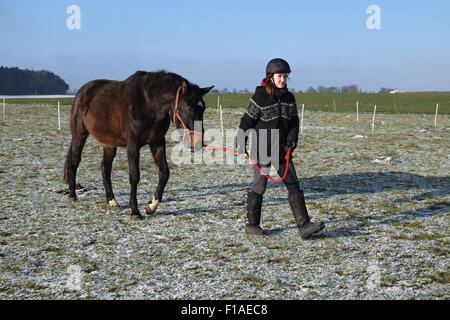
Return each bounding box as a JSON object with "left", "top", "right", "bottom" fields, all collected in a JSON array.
[{"left": 289, "top": 190, "right": 325, "bottom": 239}]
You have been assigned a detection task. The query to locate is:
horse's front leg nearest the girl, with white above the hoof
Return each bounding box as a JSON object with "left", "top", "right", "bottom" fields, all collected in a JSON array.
[{"left": 145, "top": 140, "right": 170, "bottom": 214}]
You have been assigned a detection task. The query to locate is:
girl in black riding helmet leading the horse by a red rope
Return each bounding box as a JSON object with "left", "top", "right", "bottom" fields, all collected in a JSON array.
[{"left": 237, "top": 58, "right": 325, "bottom": 239}]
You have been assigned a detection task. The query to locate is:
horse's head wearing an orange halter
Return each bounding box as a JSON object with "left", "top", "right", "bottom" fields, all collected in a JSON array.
[{"left": 172, "top": 80, "right": 214, "bottom": 150}]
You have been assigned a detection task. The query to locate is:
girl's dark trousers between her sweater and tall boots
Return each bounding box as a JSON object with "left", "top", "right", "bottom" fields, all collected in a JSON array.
[{"left": 252, "top": 159, "right": 300, "bottom": 194}]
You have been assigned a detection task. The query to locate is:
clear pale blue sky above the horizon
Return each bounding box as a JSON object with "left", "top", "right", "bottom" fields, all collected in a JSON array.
[{"left": 0, "top": 0, "right": 450, "bottom": 92}]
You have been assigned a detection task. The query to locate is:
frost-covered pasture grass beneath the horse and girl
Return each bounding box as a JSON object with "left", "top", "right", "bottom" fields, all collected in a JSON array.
[{"left": 0, "top": 105, "right": 450, "bottom": 299}]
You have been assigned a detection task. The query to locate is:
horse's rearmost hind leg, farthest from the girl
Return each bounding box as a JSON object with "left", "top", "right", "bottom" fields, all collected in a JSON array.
[{"left": 64, "top": 131, "right": 89, "bottom": 200}]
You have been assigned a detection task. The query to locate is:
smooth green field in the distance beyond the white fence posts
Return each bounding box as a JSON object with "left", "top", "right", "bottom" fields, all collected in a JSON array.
[{"left": 6, "top": 92, "right": 450, "bottom": 114}]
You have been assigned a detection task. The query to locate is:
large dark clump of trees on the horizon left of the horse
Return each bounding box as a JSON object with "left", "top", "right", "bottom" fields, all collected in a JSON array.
[{"left": 0, "top": 66, "right": 69, "bottom": 95}]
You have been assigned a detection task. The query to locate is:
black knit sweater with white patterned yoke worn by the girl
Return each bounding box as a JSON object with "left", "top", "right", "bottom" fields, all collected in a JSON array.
[{"left": 239, "top": 86, "right": 299, "bottom": 158}]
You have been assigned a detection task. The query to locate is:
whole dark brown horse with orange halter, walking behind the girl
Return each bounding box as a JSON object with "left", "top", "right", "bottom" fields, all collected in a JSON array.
[{"left": 64, "top": 71, "right": 213, "bottom": 218}]
